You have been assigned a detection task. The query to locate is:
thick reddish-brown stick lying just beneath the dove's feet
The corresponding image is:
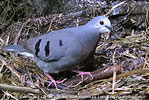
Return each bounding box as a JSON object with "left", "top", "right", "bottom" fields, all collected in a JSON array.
[{"left": 64, "top": 65, "right": 123, "bottom": 87}]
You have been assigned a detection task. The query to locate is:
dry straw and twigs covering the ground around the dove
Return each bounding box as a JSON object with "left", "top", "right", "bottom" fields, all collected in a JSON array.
[{"left": 0, "top": 2, "right": 149, "bottom": 100}]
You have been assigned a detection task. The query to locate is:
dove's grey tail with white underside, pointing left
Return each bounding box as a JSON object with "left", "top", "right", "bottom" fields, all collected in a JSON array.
[{"left": 2, "top": 45, "right": 33, "bottom": 57}]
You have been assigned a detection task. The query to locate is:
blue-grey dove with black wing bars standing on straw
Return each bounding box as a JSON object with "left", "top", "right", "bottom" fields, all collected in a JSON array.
[{"left": 2, "top": 15, "right": 112, "bottom": 89}]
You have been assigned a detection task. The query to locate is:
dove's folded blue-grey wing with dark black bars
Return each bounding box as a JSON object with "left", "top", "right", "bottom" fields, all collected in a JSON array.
[{"left": 23, "top": 30, "right": 79, "bottom": 62}]
